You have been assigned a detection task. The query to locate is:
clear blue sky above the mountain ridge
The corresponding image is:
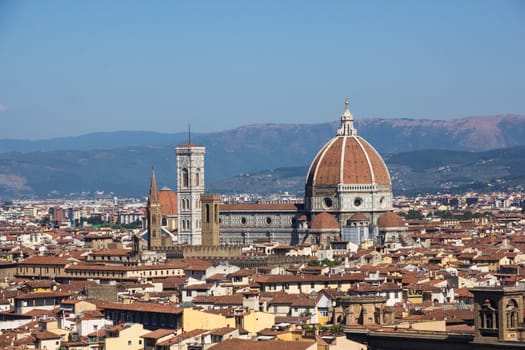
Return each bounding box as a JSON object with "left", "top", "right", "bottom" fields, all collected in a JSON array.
[{"left": 0, "top": 0, "right": 525, "bottom": 139}]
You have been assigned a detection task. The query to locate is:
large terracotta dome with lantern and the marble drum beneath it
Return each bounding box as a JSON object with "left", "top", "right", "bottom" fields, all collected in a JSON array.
[{"left": 304, "top": 100, "right": 392, "bottom": 220}]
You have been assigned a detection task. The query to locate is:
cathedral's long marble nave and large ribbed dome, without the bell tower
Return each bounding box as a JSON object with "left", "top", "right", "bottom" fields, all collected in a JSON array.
[{"left": 215, "top": 101, "right": 392, "bottom": 244}]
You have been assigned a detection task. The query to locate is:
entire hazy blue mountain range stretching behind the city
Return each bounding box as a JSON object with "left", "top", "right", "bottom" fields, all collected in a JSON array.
[{"left": 0, "top": 114, "right": 525, "bottom": 199}]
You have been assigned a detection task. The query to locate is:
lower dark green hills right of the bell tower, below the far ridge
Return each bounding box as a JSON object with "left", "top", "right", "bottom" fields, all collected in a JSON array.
[{"left": 208, "top": 146, "right": 525, "bottom": 195}]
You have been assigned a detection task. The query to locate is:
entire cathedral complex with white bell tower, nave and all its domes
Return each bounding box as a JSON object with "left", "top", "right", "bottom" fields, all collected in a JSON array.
[{"left": 147, "top": 101, "right": 403, "bottom": 249}]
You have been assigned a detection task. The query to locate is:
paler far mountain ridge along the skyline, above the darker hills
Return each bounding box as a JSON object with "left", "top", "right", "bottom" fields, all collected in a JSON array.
[{"left": 0, "top": 114, "right": 525, "bottom": 154}]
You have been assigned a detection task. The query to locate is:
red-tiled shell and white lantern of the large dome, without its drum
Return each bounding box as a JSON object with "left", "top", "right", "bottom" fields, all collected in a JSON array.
[{"left": 306, "top": 101, "right": 391, "bottom": 189}]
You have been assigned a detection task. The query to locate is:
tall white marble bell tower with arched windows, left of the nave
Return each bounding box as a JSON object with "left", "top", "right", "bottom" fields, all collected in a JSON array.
[{"left": 175, "top": 142, "right": 206, "bottom": 245}]
